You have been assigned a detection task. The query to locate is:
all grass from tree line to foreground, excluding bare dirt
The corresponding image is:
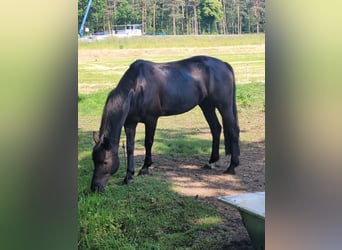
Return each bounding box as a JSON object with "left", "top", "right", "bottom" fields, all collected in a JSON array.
[{"left": 78, "top": 35, "right": 265, "bottom": 249}]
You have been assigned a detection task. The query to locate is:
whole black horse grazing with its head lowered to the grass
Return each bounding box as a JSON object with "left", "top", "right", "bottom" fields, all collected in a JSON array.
[{"left": 91, "top": 56, "right": 240, "bottom": 191}]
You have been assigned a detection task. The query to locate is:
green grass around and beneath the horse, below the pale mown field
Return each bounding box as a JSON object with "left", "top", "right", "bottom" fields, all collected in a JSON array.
[{"left": 78, "top": 83, "right": 264, "bottom": 249}]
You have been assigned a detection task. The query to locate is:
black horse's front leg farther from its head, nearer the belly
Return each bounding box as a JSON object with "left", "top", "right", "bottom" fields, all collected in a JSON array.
[{"left": 139, "top": 117, "right": 158, "bottom": 175}]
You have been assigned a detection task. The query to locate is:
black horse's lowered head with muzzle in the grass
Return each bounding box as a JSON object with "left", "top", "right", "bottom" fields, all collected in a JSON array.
[{"left": 91, "top": 132, "right": 119, "bottom": 192}]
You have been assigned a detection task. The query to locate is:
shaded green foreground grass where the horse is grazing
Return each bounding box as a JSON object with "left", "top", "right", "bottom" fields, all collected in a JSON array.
[{"left": 78, "top": 131, "right": 221, "bottom": 249}]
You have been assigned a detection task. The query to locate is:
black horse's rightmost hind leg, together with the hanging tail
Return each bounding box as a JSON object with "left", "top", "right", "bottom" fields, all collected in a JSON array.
[{"left": 219, "top": 108, "right": 240, "bottom": 174}]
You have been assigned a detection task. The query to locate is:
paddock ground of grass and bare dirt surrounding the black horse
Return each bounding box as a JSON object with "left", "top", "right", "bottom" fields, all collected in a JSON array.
[{"left": 78, "top": 34, "right": 265, "bottom": 249}]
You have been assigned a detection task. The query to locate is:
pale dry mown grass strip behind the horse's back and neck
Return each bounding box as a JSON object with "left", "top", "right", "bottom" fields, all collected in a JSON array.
[{"left": 78, "top": 44, "right": 265, "bottom": 94}]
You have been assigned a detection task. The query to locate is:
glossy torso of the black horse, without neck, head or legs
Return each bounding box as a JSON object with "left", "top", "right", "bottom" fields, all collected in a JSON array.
[{"left": 125, "top": 56, "right": 234, "bottom": 115}]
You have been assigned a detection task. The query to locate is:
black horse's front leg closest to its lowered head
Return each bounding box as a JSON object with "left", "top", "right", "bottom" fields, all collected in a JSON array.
[{"left": 124, "top": 124, "right": 137, "bottom": 184}]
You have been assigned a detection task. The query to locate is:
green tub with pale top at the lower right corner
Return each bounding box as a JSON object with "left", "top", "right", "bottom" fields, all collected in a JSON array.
[{"left": 218, "top": 192, "right": 265, "bottom": 250}]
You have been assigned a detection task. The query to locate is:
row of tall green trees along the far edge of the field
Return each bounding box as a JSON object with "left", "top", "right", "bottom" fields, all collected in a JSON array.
[{"left": 78, "top": 0, "right": 265, "bottom": 35}]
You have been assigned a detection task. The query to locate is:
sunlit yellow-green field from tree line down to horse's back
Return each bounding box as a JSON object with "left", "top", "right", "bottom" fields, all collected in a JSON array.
[{"left": 78, "top": 35, "right": 265, "bottom": 93}]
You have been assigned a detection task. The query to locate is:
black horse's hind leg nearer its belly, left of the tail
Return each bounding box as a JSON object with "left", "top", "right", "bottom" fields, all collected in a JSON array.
[{"left": 199, "top": 102, "right": 222, "bottom": 167}]
